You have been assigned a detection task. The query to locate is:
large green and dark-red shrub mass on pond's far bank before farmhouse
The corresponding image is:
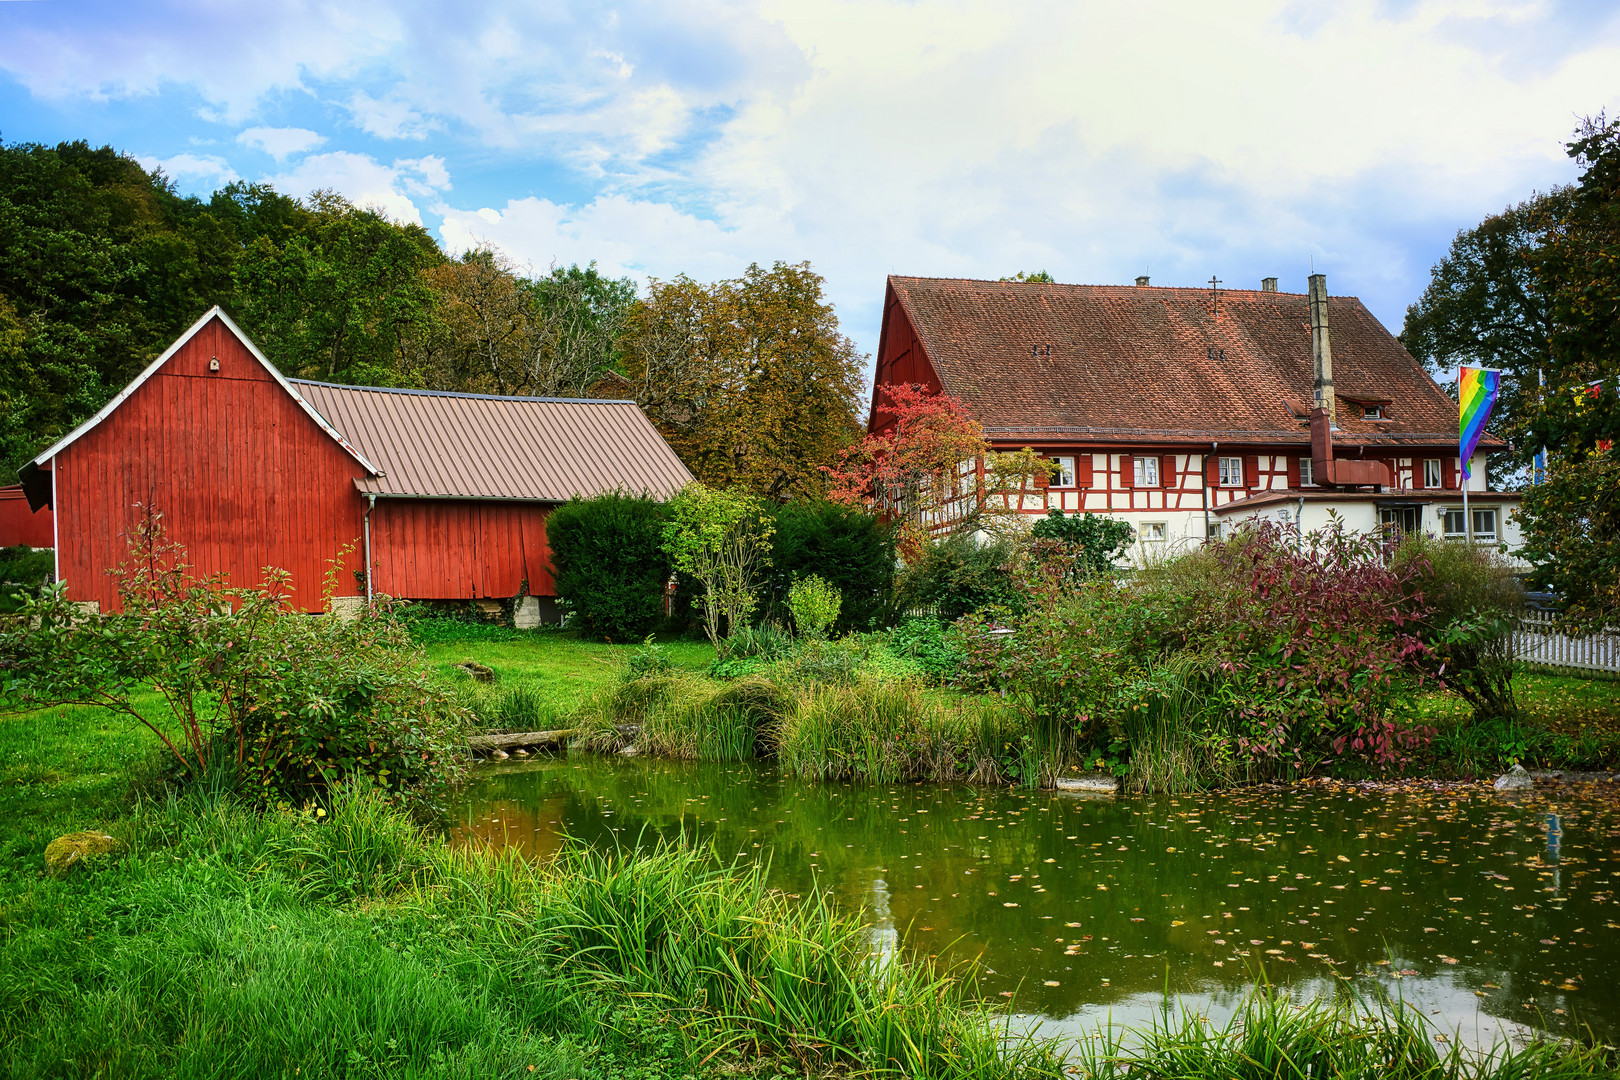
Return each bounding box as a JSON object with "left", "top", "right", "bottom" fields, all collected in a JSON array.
[{"left": 962, "top": 523, "right": 1432, "bottom": 790}]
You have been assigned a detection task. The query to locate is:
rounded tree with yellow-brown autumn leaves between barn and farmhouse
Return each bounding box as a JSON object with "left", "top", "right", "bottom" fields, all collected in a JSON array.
[{"left": 622, "top": 262, "right": 863, "bottom": 499}]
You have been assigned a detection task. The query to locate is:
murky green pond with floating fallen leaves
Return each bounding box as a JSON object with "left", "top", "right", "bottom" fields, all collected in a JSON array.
[{"left": 455, "top": 756, "right": 1620, "bottom": 1044}]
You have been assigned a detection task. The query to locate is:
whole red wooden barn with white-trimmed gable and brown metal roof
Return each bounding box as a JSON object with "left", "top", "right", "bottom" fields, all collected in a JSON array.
[{"left": 23, "top": 308, "right": 692, "bottom": 610}]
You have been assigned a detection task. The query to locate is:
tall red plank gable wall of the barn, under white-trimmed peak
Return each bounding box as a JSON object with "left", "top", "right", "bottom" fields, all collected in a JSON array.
[{"left": 52, "top": 319, "right": 365, "bottom": 610}]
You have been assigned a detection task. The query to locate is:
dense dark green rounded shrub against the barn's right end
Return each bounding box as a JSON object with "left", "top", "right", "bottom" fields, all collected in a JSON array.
[{"left": 546, "top": 491, "right": 671, "bottom": 641}]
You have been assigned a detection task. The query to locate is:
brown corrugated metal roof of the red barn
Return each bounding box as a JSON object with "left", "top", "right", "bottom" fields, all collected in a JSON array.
[{"left": 288, "top": 379, "right": 692, "bottom": 502}]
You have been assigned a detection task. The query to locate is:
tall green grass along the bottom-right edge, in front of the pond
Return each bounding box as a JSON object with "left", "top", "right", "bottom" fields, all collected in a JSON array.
[{"left": 1076, "top": 988, "right": 1620, "bottom": 1080}]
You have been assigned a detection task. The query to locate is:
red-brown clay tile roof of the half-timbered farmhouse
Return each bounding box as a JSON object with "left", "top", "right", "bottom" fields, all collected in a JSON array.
[{"left": 880, "top": 277, "right": 1483, "bottom": 445}]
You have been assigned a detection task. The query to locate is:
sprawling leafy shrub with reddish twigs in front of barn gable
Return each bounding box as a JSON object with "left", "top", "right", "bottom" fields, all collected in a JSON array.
[{"left": 0, "top": 512, "right": 468, "bottom": 808}]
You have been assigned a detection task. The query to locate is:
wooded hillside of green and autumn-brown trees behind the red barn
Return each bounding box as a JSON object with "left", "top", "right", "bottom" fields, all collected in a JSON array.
[{"left": 0, "top": 141, "right": 863, "bottom": 497}]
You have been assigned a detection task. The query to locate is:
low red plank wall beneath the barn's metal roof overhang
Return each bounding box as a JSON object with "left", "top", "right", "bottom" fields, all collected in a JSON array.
[{"left": 371, "top": 499, "right": 556, "bottom": 601}]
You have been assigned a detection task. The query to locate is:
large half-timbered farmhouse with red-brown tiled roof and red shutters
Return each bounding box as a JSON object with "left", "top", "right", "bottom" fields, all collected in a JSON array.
[{"left": 868, "top": 275, "right": 1518, "bottom": 554}]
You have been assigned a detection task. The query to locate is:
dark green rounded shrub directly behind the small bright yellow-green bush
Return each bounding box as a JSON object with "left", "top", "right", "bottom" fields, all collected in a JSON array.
[{"left": 763, "top": 502, "right": 894, "bottom": 633}]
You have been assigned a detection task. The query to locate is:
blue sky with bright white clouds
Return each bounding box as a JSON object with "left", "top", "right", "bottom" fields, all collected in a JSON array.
[{"left": 0, "top": 0, "right": 1620, "bottom": 369}]
